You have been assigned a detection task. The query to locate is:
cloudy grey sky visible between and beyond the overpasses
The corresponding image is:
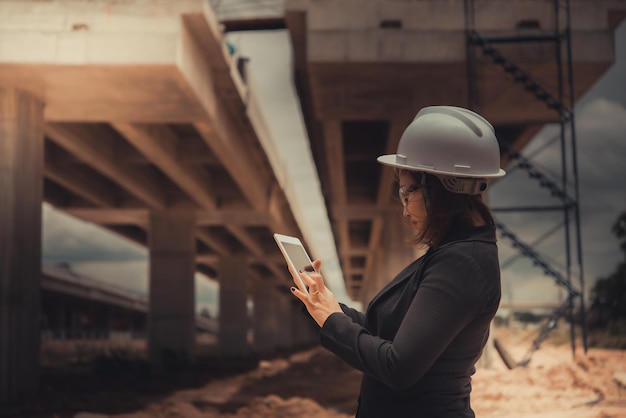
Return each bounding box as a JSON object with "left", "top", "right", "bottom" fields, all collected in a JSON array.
[{"left": 42, "top": 11, "right": 626, "bottom": 314}]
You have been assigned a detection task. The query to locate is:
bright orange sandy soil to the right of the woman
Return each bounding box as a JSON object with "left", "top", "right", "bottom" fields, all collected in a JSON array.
[{"left": 472, "top": 334, "right": 626, "bottom": 418}]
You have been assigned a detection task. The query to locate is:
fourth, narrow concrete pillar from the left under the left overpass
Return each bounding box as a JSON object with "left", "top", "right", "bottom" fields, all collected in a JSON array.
[{"left": 253, "top": 280, "right": 279, "bottom": 354}]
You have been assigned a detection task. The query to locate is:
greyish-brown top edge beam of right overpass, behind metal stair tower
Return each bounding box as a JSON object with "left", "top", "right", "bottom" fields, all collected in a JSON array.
[{"left": 285, "top": 0, "right": 625, "bottom": 62}]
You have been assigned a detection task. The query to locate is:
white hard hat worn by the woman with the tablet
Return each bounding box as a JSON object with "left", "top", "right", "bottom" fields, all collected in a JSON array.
[{"left": 377, "top": 106, "right": 506, "bottom": 185}]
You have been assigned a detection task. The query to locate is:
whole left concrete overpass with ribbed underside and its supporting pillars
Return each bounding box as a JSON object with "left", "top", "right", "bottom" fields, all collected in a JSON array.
[{"left": 0, "top": 0, "right": 315, "bottom": 404}]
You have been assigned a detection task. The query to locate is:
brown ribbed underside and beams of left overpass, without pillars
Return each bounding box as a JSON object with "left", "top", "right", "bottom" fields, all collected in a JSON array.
[{"left": 0, "top": 13, "right": 298, "bottom": 280}]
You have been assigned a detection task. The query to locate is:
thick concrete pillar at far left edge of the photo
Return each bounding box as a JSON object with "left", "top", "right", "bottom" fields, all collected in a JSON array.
[{"left": 0, "top": 88, "right": 44, "bottom": 404}]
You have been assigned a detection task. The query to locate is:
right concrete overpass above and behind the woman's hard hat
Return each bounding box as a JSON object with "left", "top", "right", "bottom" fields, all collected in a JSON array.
[{"left": 285, "top": 0, "right": 626, "bottom": 304}]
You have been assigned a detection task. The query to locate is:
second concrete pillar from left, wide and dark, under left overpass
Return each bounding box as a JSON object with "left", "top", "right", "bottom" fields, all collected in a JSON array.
[{"left": 148, "top": 210, "right": 196, "bottom": 371}]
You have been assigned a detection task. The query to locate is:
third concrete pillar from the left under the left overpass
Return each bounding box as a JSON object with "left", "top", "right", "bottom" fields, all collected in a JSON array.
[{"left": 218, "top": 255, "right": 250, "bottom": 358}]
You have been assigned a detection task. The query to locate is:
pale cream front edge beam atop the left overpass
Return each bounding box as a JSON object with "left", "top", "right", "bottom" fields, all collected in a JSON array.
[{"left": 0, "top": 0, "right": 205, "bottom": 65}]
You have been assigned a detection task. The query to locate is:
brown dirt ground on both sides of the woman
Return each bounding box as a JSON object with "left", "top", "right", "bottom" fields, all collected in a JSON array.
[{"left": 7, "top": 332, "right": 626, "bottom": 418}]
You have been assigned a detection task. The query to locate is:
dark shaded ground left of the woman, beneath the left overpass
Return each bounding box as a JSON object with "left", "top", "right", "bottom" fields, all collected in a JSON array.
[{"left": 0, "top": 348, "right": 361, "bottom": 418}]
